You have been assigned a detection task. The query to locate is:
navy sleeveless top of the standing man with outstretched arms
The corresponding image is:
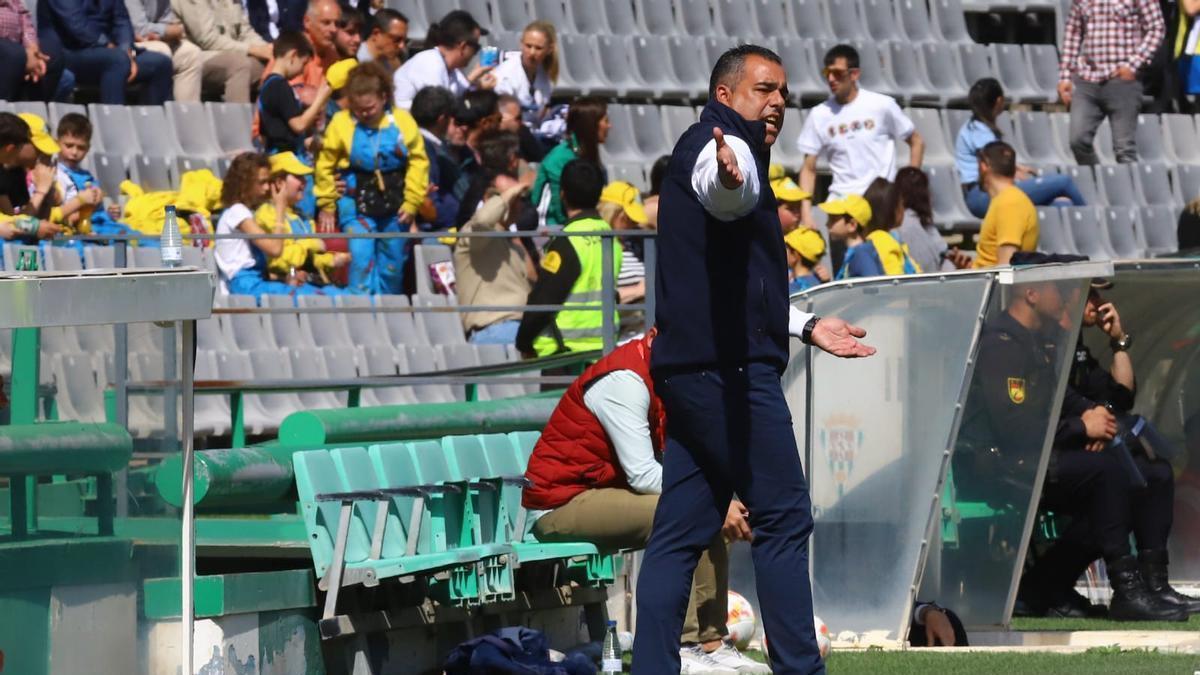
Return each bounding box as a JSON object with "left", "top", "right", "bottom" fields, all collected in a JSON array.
[{"left": 650, "top": 101, "right": 787, "bottom": 375}]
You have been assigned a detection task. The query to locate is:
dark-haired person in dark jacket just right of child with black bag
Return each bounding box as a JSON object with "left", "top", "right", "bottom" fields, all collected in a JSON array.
[{"left": 412, "top": 86, "right": 458, "bottom": 231}]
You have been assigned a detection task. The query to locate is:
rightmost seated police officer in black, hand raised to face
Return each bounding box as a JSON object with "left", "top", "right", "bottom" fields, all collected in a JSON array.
[{"left": 1038, "top": 279, "right": 1200, "bottom": 616}]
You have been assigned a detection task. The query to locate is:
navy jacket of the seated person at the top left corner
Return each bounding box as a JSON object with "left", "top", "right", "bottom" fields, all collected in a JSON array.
[{"left": 37, "top": 0, "right": 133, "bottom": 52}]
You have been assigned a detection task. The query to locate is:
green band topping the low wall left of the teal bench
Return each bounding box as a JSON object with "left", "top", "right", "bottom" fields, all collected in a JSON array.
[{"left": 142, "top": 569, "right": 317, "bottom": 620}]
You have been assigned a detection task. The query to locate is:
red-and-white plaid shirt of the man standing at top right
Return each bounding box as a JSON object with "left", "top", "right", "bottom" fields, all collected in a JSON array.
[{"left": 1058, "top": 0, "right": 1166, "bottom": 82}]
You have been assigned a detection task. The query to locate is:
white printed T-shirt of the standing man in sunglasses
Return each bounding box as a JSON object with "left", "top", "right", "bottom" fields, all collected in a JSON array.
[{"left": 797, "top": 88, "right": 913, "bottom": 197}]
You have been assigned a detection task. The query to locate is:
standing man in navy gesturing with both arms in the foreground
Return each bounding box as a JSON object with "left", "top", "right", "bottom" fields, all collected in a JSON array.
[{"left": 632, "top": 44, "right": 875, "bottom": 675}]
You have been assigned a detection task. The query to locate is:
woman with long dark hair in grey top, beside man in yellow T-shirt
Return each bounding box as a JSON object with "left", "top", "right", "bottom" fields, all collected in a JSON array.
[{"left": 893, "top": 161, "right": 979, "bottom": 271}]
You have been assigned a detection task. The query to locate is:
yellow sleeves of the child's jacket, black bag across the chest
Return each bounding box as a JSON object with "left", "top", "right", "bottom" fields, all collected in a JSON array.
[{"left": 313, "top": 108, "right": 430, "bottom": 215}]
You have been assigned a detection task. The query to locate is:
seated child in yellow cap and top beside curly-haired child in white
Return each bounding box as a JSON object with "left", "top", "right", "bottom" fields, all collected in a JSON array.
[{"left": 254, "top": 153, "right": 350, "bottom": 289}]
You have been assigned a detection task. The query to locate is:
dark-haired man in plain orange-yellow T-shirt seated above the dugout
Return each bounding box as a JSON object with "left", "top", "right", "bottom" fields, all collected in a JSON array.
[{"left": 974, "top": 141, "right": 1038, "bottom": 268}]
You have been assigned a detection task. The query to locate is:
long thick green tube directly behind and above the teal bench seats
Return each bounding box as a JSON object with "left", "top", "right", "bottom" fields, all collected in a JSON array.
[{"left": 280, "top": 392, "right": 562, "bottom": 448}]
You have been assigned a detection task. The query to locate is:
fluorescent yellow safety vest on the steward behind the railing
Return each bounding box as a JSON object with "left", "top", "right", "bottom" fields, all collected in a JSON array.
[{"left": 533, "top": 217, "right": 622, "bottom": 357}]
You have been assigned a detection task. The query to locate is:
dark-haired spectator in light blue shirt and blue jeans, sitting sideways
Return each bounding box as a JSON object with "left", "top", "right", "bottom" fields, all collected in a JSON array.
[{"left": 954, "top": 77, "right": 1086, "bottom": 217}]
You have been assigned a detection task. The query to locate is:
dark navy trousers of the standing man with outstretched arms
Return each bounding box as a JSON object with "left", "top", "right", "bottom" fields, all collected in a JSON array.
[{"left": 632, "top": 363, "right": 824, "bottom": 675}]
